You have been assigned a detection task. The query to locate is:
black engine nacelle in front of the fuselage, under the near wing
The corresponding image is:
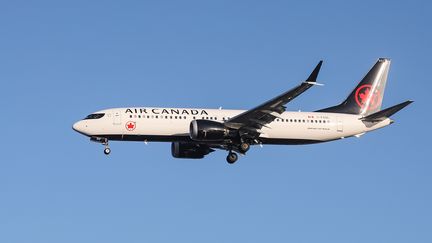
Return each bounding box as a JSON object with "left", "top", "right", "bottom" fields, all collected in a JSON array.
[{"left": 189, "top": 120, "right": 229, "bottom": 141}]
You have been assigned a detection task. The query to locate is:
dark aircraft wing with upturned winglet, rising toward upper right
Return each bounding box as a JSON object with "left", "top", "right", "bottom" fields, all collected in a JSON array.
[{"left": 225, "top": 61, "right": 323, "bottom": 137}]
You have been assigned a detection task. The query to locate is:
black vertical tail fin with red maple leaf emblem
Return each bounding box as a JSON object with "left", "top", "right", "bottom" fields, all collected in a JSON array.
[{"left": 319, "top": 58, "right": 390, "bottom": 116}]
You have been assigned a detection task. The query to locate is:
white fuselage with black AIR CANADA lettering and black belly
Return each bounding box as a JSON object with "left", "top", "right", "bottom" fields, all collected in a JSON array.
[{"left": 73, "top": 107, "right": 391, "bottom": 144}]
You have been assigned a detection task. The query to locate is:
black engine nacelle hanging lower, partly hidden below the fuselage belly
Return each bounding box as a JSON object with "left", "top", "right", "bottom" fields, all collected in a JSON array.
[{"left": 171, "top": 142, "right": 214, "bottom": 159}]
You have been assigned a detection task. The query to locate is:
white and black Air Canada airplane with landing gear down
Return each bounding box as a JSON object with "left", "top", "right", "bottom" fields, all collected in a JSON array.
[{"left": 73, "top": 58, "right": 413, "bottom": 164}]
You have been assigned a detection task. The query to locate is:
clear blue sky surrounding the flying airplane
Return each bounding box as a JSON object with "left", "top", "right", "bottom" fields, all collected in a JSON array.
[{"left": 0, "top": 1, "right": 432, "bottom": 243}]
